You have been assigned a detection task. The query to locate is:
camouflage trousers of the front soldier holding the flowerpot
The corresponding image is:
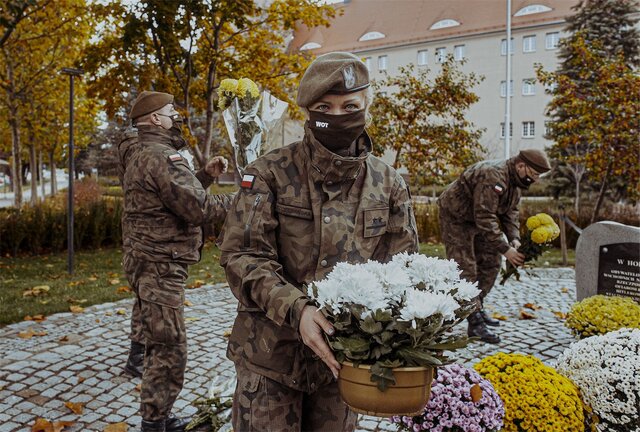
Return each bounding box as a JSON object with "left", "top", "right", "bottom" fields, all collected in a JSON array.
[{"left": 232, "top": 367, "right": 358, "bottom": 432}]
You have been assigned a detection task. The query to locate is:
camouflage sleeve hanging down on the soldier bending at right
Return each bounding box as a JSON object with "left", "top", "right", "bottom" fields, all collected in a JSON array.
[{"left": 473, "top": 179, "right": 509, "bottom": 254}]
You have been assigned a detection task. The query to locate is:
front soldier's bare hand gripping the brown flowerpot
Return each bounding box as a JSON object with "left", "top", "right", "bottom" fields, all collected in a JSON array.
[{"left": 299, "top": 305, "right": 340, "bottom": 378}]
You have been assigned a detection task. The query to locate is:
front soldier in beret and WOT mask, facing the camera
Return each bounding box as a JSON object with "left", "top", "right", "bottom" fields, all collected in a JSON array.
[{"left": 220, "top": 53, "right": 418, "bottom": 432}]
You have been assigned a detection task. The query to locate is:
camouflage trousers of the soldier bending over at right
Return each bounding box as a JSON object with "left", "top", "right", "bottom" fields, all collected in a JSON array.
[{"left": 440, "top": 209, "right": 502, "bottom": 304}]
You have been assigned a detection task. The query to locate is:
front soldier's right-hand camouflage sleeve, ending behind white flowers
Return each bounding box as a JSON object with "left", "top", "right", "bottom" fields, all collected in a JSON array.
[{"left": 372, "top": 175, "right": 418, "bottom": 262}]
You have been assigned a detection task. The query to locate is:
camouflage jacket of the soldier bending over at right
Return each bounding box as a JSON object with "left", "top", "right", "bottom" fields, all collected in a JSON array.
[{"left": 438, "top": 159, "right": 521, "bottom": 254}]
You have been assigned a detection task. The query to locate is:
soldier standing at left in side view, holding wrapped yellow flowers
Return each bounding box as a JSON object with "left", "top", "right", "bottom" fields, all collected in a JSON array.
[{"left": 118, "top": 91, "right": 231, "bottom": 432}]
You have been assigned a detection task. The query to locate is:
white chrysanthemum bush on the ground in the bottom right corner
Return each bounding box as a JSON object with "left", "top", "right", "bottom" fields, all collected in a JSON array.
[{"left": 557, "top": 328, "right": 640, "bottom": 432}]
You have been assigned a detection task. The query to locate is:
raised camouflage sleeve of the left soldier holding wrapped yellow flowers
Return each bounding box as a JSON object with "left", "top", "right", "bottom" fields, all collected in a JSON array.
[{"left": 149, "top": 154, "right": 230, "bottom": 226}]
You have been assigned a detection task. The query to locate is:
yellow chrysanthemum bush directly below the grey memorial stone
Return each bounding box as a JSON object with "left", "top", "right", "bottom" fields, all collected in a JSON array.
[{"left": 564, "top": 295, "right": 640, "bottom": 339}]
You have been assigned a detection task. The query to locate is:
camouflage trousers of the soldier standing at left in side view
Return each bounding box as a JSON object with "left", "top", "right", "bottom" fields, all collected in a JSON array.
[{"left": 123, "top": 255, "right": 187, "bottom": 421}]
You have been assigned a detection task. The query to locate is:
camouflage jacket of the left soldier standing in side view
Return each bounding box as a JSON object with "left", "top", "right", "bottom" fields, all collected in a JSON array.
[{"left": 118, "top": 126, "right": 231, "bottom": 264}]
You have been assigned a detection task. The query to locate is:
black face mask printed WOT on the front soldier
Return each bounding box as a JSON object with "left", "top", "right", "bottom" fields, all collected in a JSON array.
[{"left": 309, "top": 110, "right": 365, "bottom": 156}]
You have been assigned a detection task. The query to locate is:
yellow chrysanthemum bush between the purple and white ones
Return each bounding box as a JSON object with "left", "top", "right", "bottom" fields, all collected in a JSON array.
[{"left": 475, "top": 353, "right": 584, "bottom": 432}]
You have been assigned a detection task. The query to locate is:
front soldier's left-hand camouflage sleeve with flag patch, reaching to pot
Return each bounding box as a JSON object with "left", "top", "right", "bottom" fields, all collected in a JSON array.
[{"left": 219, "top": 171, "right": 308, "bottom": 330}]
